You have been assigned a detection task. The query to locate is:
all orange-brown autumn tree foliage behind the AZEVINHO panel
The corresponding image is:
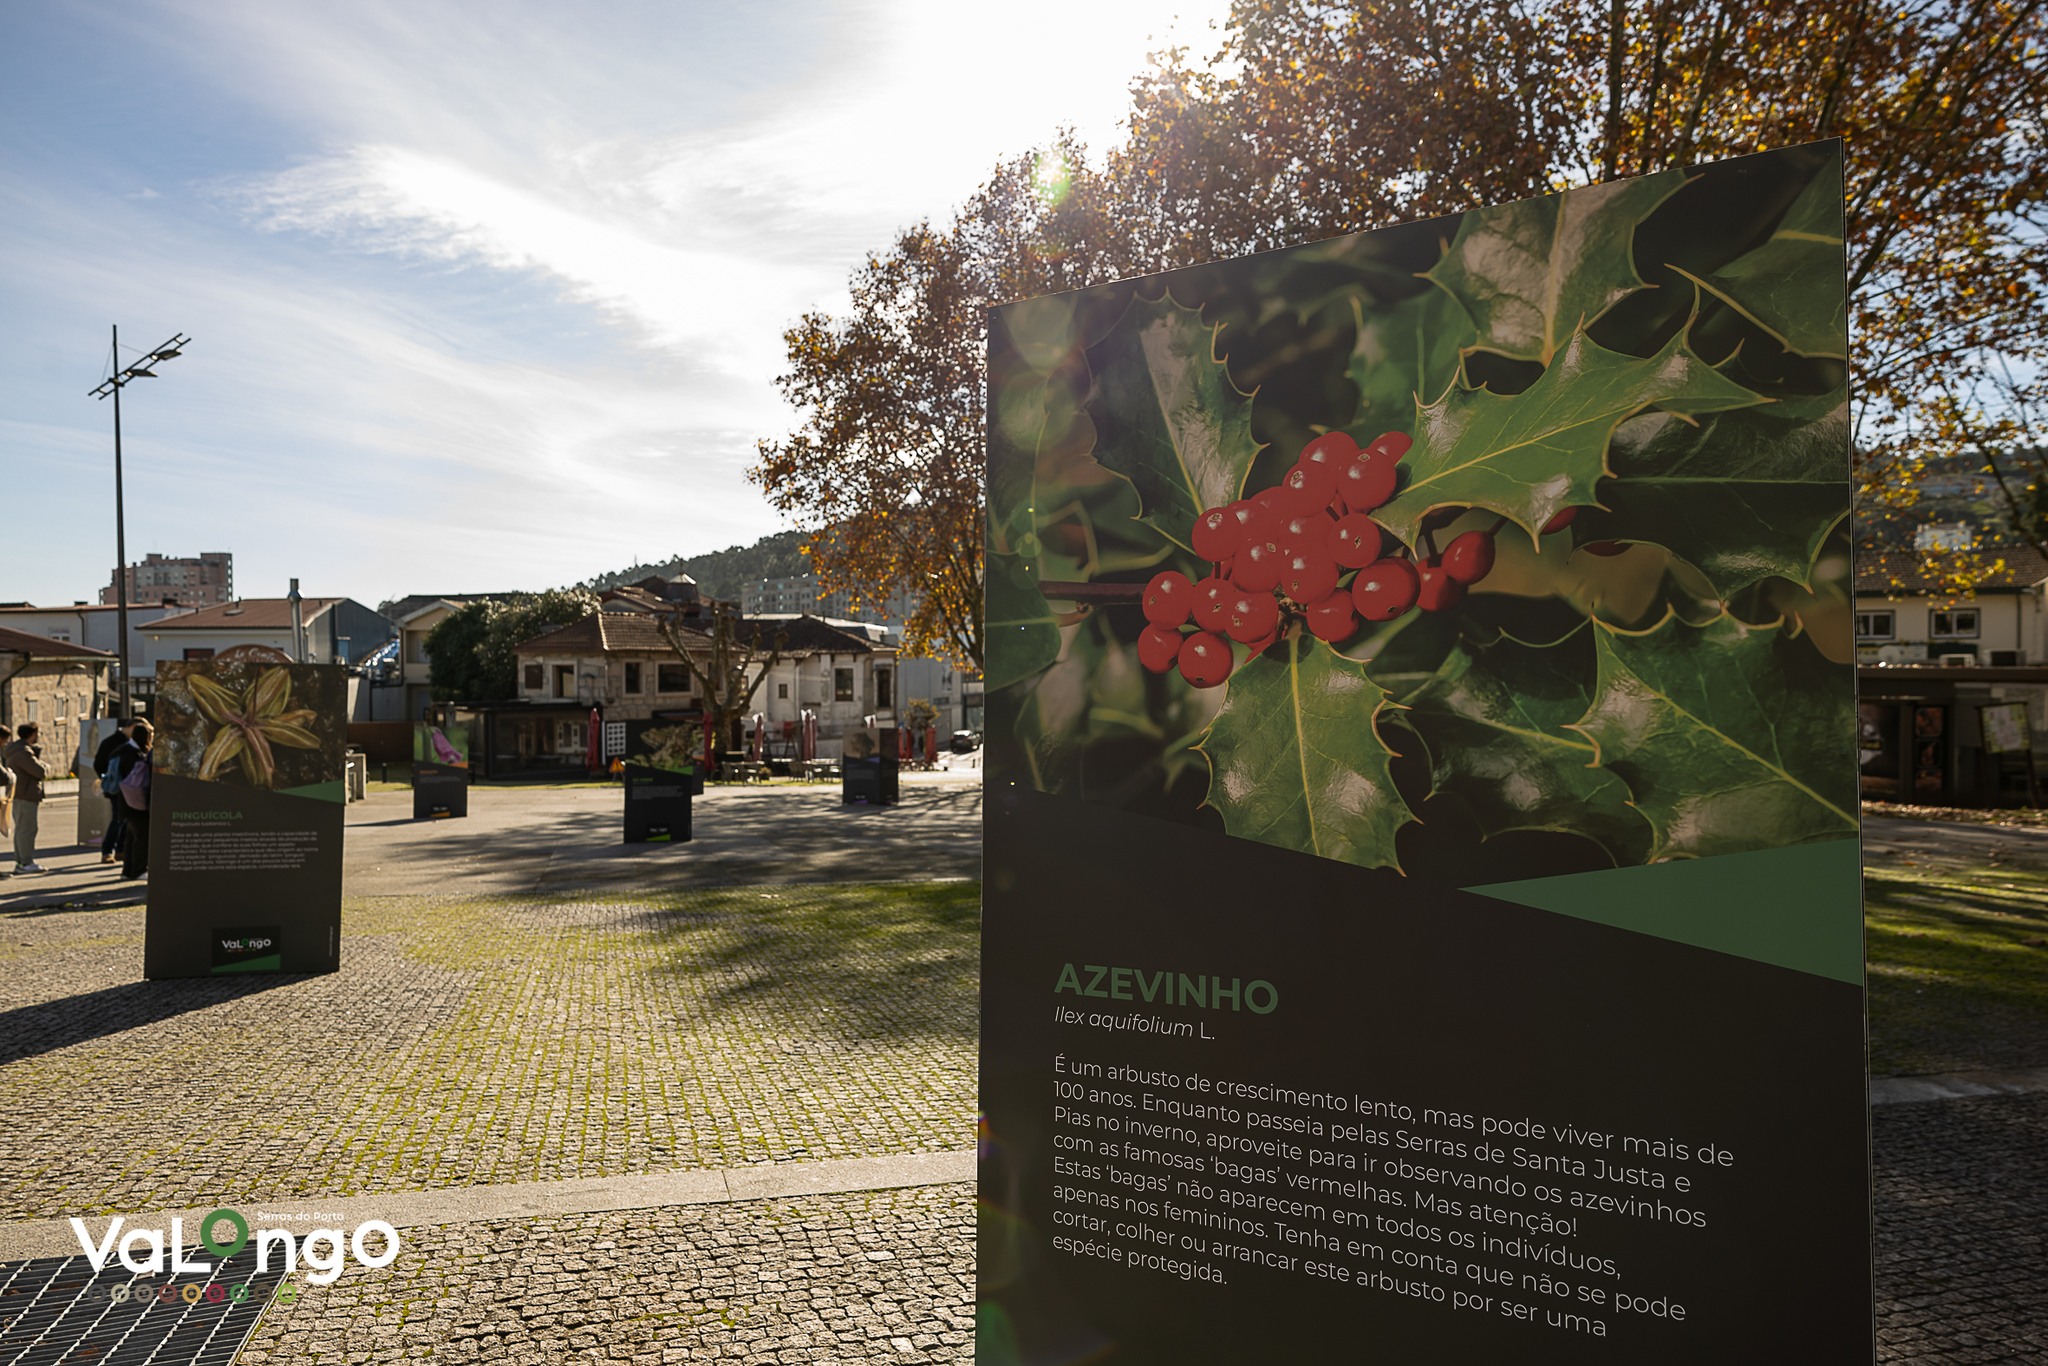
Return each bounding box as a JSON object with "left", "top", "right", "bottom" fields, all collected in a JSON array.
[{"left": 754, "top": 0, "right": 2048, "bottom": 618}]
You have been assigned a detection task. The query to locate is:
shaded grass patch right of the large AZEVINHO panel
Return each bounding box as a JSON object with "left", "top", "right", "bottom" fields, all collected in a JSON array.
[{"left": 1864, "top": 866, "right": 2048, "bottom": 1077}]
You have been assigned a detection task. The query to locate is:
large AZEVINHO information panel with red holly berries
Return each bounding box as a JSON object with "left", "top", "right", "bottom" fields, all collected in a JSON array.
[{"left": 979, "top": 143, "right": 1872, "bottom": 1366}]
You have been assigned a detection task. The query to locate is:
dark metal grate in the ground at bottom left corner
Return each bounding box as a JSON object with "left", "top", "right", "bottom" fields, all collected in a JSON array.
[{"left": 0, "top": 1247, "right": 285, "bottom": 1366}]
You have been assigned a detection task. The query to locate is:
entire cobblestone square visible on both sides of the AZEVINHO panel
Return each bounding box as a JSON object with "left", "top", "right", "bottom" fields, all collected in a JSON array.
[{"left": 0, "top": 802, "right": 2048, "bottom": 1366}]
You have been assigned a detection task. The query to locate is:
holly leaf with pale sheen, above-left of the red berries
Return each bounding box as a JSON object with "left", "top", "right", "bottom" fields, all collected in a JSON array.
[{"left": 1087, "top": 299, "right": 1260, "bottom": 549}]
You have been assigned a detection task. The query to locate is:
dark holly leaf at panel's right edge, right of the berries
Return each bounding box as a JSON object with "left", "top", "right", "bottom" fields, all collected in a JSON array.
[{"left": 1579, "top": 391, "right": 1849, "bottom": 598}]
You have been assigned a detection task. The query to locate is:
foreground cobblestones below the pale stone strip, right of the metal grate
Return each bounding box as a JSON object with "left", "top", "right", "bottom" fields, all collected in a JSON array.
[{"left": 240, "top": 1186, "right": 975, "bottom": 1366}]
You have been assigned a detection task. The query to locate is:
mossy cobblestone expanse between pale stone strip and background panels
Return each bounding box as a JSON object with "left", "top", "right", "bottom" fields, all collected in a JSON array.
[{"left": 0, "top": 883, "right": 979, "bottom": 1219}]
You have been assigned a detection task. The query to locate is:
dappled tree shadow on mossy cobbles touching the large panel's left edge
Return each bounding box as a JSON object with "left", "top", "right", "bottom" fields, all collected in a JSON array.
[{"left": 641, "top": 883, "right": 981, "bottom": 1044}]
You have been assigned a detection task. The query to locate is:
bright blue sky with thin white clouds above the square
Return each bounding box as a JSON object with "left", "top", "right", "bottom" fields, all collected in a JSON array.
[{"left": 0, "top": 0, "right": 1225, "bottom": 604}]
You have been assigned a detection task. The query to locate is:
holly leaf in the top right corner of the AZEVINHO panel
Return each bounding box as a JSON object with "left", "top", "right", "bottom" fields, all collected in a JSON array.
[{"left": 1698, "top": 156, "right": 1849, "bottom": 358}]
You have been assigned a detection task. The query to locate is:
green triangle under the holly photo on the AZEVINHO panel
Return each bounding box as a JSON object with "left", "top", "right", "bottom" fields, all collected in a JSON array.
[{"left": 1466, "top": 840, "right": 1864, "bottom": 987}]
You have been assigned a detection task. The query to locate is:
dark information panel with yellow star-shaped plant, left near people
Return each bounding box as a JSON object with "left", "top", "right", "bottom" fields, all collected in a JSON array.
[{"left": 131, "top": 659, "right": 348, "bottom": 977}]
